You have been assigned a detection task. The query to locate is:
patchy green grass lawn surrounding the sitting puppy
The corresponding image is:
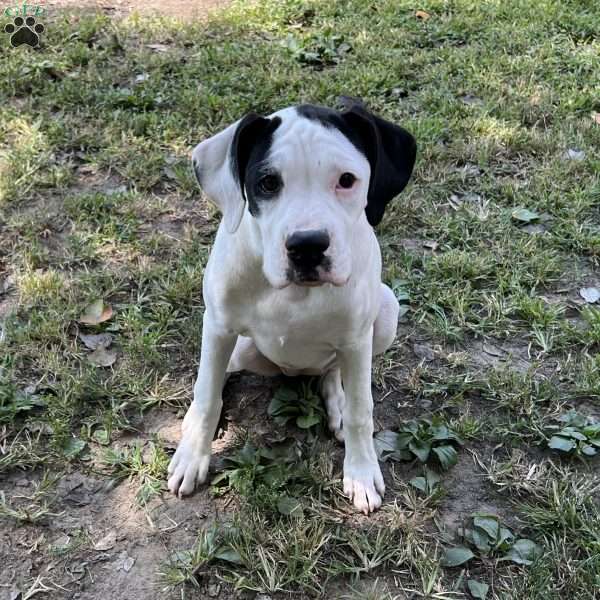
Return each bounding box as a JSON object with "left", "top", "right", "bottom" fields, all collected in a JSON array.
[{"left": 0, "top": 0, "right": 600, "bottom": 599}]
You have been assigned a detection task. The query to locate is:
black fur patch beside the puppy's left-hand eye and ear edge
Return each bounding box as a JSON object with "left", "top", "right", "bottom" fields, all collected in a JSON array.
[{"left": 230, "top": 113, "right": 281, "bottom": 217}]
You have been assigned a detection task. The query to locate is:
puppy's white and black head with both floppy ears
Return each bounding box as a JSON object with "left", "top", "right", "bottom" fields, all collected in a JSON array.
[{"left": 192, "top": 105, "right": 416, "bottom": 288}]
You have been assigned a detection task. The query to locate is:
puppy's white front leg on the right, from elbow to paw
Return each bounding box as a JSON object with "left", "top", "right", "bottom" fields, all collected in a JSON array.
[{"left": 338, "top": 332, "right": 385, "bottom": 514}]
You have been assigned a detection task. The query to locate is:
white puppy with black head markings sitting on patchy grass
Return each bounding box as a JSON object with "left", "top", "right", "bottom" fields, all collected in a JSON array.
[{"left": 168, "top": 104, "right": 416, "bottom": 514}]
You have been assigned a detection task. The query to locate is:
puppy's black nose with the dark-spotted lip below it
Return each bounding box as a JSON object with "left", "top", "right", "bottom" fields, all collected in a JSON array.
[{"left": 285, "top": 229, "right": 330, "bottom": 285}]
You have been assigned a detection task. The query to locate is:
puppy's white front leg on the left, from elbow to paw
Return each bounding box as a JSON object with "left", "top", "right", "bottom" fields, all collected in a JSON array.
[{"left": 168, "top": 310, "right": 237, "bottom": 496}]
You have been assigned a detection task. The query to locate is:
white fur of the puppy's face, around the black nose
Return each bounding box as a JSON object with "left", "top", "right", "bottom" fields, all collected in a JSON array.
[{"left": 256, "top": 109, "right": 370, "bottom": 288}]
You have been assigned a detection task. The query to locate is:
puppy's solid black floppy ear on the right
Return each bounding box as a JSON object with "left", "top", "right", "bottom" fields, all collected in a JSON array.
[{"left": 342, "top": 104, "right": 417, "bottom": 226}]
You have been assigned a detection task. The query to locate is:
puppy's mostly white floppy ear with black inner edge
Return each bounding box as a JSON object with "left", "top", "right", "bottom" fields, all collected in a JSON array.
[{"left": 192, "top": 113, "right": 273, "bottom": 233}]
